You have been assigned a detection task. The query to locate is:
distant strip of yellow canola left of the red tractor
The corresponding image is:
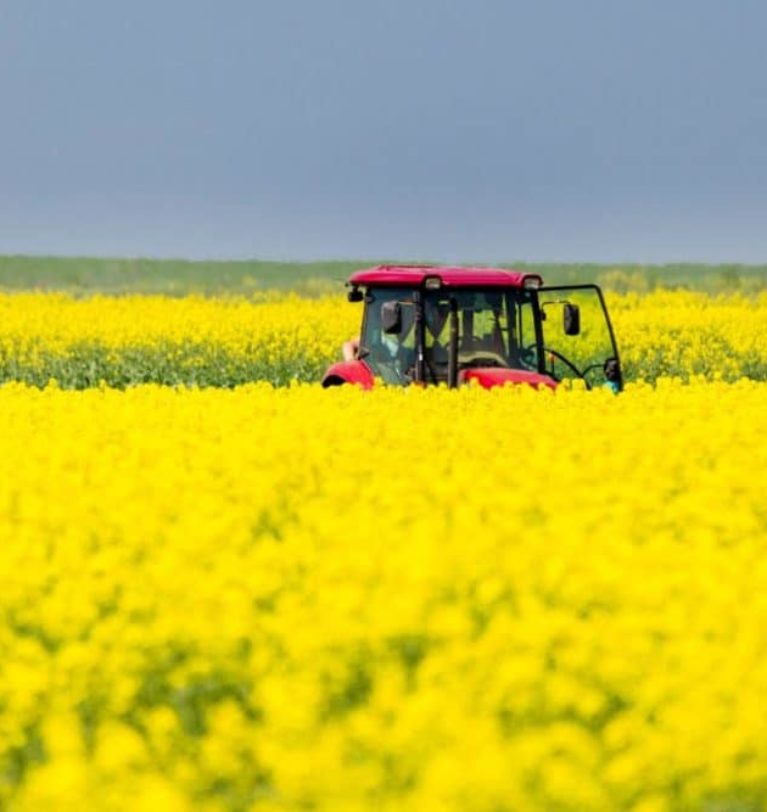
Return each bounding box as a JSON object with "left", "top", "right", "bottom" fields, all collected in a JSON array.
[{"left": 0, "top": 293, "right": 360, "bottom": 388}]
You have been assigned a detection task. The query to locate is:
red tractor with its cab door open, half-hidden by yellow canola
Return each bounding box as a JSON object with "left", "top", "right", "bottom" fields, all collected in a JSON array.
[{"left": 322, "top": 265, "right": 623, "bottom": 392}]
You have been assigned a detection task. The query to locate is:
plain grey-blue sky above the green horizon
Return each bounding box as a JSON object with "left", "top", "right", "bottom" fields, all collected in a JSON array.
[{"left": 0, "top": 0, "right": 767, "bottom": 263}]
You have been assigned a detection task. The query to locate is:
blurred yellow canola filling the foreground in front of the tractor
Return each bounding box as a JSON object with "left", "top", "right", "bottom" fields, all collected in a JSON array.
[{"left": 0, "top": 380, "right": 767, "bottom": 810}]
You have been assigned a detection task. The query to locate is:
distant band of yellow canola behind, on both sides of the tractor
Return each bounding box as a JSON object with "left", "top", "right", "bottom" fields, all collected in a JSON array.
[{"left": 0, "top": 291, "right": 767, "bottom": 388}]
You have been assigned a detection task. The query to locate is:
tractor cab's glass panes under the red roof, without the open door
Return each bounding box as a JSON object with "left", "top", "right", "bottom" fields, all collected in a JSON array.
[{"left": 360, "top": 288, "right": 539, "bottom": 384}]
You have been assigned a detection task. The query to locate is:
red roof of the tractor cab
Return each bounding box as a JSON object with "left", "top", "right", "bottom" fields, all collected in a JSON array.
[{"left": 349, "top": 265, "right": 543, "bottom": 288}]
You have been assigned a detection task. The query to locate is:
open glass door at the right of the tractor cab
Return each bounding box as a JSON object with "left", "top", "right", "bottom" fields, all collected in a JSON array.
[{"left": 538, "top": 285, "right": 623, "bottom": 392}]
